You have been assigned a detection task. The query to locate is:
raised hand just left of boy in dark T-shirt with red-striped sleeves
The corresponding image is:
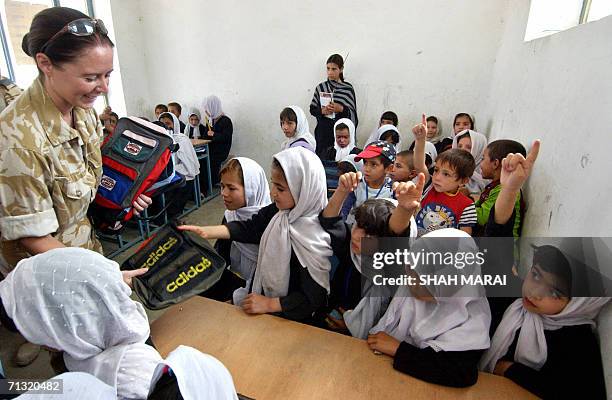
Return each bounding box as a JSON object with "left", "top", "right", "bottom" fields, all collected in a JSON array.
[{"left": 389, "top": 173, "right": 425, "bottom": 235}]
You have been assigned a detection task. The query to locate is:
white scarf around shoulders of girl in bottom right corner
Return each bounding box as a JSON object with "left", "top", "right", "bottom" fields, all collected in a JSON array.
[{"left": 479, "top": 297, "right": 610, "bottom": 372}]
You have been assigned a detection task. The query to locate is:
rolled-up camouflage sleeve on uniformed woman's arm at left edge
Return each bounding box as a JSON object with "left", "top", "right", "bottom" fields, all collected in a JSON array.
[{"left": 0, "top": 149, "right": 59, "bottom": 240}]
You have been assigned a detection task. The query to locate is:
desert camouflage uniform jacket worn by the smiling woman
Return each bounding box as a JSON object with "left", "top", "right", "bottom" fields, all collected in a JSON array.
[{"left": 0, "top": 78, "right": 102, "bottom": 266}]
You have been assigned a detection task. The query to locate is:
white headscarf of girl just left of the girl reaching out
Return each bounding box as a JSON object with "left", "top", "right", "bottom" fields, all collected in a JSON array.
[{"left": 225, "top": 157, "right": 272, "bottom": 304}]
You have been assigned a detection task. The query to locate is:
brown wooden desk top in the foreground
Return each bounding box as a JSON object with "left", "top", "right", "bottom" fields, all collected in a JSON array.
[{"left": 151, "top": 296, "right": 535, "bottom": 400}]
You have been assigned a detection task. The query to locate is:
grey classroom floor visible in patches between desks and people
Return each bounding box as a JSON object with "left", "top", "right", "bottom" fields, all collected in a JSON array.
[{"left": 0, "top": 196, "right": 225, "bottom": 379}]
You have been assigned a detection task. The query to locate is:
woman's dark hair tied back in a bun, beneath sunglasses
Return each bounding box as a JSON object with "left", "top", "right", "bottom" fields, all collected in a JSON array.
[{"left": 21, "top": 7, "right": 115, "bottom": 64}]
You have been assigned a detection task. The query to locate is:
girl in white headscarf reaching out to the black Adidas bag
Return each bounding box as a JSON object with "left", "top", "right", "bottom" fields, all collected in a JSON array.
[{"left": 181, "top": 147, "right": 332, "bottom": 322}]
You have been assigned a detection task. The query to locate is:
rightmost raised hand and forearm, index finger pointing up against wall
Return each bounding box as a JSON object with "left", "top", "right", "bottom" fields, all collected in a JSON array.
[{"left": 494, "top": 140, "right": 540, "bottom": 225}]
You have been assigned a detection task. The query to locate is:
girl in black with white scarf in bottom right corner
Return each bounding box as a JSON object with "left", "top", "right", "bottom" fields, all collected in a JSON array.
[{"left": 480, "top": 244, "right": 610, "bottom": 398}]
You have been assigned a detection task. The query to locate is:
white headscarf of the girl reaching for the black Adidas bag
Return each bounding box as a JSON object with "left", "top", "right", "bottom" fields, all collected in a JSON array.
[{"left": 253, "top": 147, "right": 332, "bottom": 297}]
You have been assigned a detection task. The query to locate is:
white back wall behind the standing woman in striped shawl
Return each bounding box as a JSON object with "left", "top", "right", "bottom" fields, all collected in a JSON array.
[{"left": 111, "top": 0, "right": 507, "bottom": 170}]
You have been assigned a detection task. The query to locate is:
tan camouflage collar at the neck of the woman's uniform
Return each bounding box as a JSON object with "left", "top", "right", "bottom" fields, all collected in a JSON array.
[{"left": 30, "top": 77, "right": 85, "bottom": 146}]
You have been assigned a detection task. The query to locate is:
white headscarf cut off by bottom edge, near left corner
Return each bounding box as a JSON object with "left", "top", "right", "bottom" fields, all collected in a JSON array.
[{"left": 17, "top": 372, "right": 117, "bottom": 400}]
